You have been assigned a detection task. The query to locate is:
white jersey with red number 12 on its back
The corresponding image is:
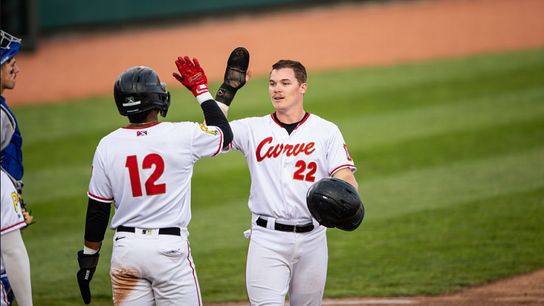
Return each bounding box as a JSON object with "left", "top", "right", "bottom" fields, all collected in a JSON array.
[{"left": 88, "top": 122, "right": 223, "bottom": 228}]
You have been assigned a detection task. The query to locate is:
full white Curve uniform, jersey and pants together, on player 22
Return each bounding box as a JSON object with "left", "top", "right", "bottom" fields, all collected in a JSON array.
[{"left": 230, "top": 114, "right": 356, "bottom": 306}]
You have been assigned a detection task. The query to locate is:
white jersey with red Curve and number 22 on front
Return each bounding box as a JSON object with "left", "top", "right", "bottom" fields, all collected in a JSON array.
[{"left": 226, "top": 114, "right": 356, "bottom": 221}]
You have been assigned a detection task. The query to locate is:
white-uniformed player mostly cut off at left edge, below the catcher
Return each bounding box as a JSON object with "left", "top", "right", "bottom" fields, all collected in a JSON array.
[{"left": 0, "top": 170, "right": 32, "bottom": 306}]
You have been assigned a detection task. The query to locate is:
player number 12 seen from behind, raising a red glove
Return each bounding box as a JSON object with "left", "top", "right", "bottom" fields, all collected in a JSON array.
[{"left": 77, "top": 57, "right": 232, "bottom": 305}]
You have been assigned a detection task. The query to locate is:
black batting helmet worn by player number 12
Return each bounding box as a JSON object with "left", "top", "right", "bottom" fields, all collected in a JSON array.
[{"left": 113, "top": 66, "right": 170, "bottom": 117}]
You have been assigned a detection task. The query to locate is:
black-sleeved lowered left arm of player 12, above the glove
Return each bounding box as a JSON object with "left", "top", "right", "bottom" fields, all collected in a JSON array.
[{"left": 85, "top": 198, "right": 111, "bottom": 246}]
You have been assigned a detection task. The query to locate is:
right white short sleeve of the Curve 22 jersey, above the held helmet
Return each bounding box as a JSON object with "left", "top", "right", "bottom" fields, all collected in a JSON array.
[{"left": 327, "top": 126, "right": 357, "bottom": 176}]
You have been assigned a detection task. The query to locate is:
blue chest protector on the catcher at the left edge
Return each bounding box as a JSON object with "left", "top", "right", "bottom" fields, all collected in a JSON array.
[{"left": 0, "top": 96, "right": 23, "bottom": 181}]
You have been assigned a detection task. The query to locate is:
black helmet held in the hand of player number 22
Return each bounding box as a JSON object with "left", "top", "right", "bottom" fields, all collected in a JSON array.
[{"left": 306, "top": 177, "right": 365, "bottom": 231}]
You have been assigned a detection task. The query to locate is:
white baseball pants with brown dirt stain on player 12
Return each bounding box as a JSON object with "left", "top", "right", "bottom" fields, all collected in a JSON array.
[{"left": 110, "top": 229, "right": 202, "bottom": 306}]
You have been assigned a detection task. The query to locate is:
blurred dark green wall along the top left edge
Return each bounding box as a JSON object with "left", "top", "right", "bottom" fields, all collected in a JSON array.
[{"left": 1, "top": 0, "right": 374, "bottom": 51}]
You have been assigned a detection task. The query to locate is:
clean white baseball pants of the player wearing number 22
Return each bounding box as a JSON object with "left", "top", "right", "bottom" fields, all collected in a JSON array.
[{"left": 246, "top": 224, "right": 328, "bottom": 306}]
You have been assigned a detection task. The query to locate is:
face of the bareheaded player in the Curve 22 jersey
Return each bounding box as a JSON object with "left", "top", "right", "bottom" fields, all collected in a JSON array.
[{"left": 268, "top": 68, "right": 308, "bottom": 112}]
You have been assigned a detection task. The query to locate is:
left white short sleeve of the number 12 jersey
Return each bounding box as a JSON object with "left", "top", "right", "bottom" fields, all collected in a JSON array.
[{"left": 87, "top": 145, "right": 113, "bottom": 203}]
